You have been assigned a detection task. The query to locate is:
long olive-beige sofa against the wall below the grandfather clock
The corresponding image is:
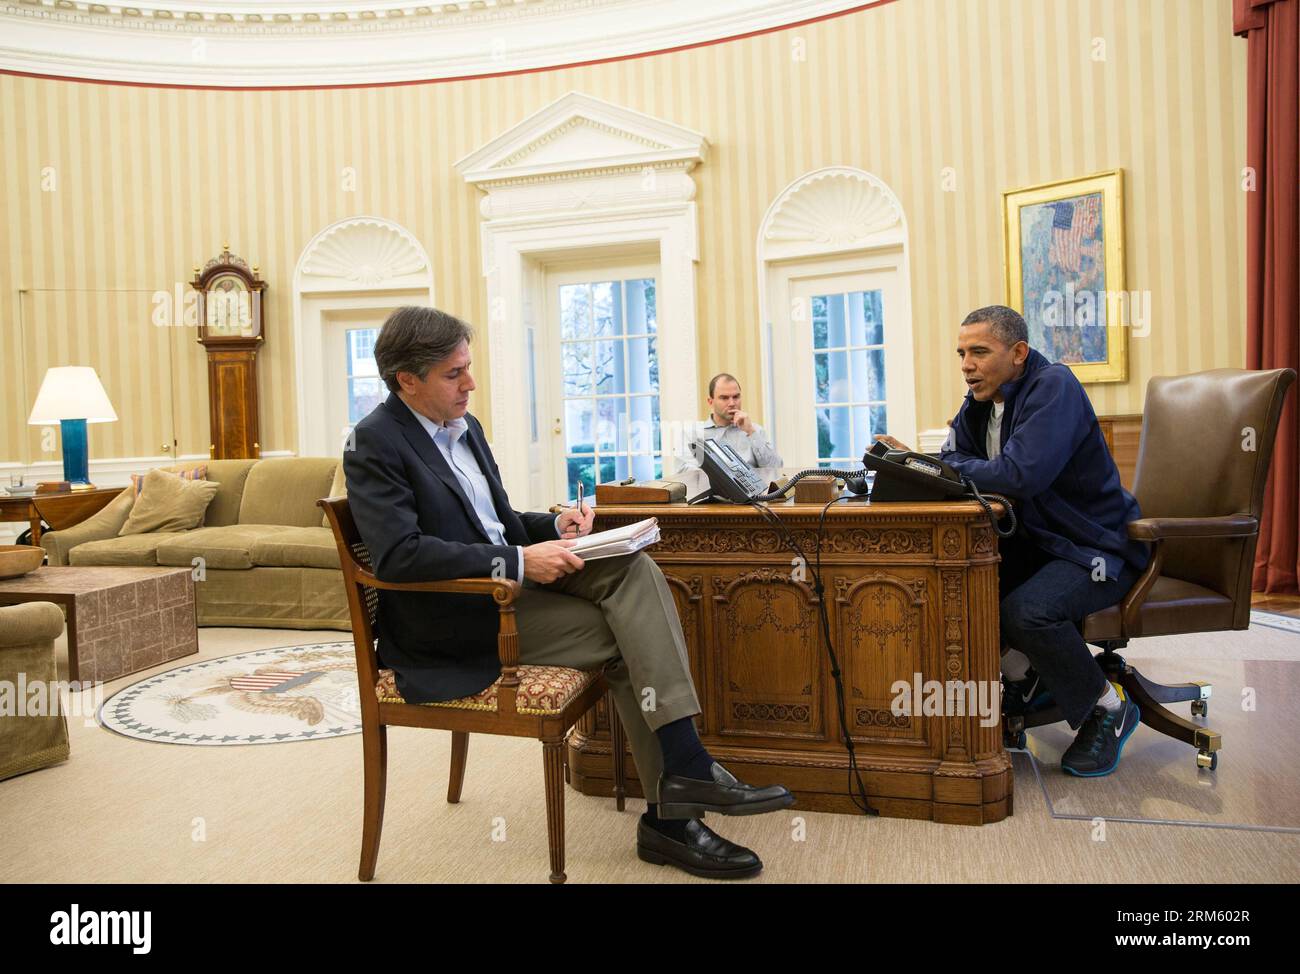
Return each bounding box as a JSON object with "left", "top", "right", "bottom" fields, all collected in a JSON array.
[{"left": 40, "top": 456, "right": 351, "bottom": 629}]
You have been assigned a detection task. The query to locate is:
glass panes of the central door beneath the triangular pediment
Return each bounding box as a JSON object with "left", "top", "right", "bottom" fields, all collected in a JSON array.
[{"left": 559, "top": 277, "right": 663, "bottom": 497}]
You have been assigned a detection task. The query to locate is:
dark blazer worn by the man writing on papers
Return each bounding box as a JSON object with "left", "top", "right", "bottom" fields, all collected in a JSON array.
[{"left": 343, "top": 393, "right": 558, "bottom": 704}]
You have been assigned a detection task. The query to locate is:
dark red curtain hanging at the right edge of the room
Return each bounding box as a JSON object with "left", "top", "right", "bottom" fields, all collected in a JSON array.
[{"left": 1232, "top": 0, "right": 1300, "bottom": 593}]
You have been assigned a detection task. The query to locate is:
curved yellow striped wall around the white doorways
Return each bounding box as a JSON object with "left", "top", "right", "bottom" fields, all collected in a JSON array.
[{"left": 0, "top": 0, "right": 1245, "bottom": 462}]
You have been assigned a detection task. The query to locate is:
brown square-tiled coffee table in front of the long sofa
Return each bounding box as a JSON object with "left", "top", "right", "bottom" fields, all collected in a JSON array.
[{"left": 0, "top": 566, "right": 199, "bottom": 683}]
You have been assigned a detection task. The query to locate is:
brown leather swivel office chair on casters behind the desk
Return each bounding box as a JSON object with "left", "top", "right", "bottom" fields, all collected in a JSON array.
[{"left": 1004, "top": 368, "right": 1296, "bottom": 771}]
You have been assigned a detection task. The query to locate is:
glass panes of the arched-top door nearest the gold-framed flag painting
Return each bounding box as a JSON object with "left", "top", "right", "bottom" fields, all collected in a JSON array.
[{"left": 810, "top": 290, "right": 889, "bottom": 467}]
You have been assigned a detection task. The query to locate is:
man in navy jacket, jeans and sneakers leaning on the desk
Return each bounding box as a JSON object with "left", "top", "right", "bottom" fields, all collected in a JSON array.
[{"left": 879, "top": 304, "right": 1151, "bottom": 778}]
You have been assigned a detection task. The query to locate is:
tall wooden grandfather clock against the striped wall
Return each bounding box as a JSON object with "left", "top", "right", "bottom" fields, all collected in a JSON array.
[{"left": 190, "top": 243, "right": 267, "bottom": 460}]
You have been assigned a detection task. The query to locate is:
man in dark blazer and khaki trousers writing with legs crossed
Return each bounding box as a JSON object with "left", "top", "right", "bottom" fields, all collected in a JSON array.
[{"left": 343, "top": 307, "right": 794, "bottom": 878}]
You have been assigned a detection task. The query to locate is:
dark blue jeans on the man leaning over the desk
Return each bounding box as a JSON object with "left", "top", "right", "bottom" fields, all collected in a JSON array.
[{"left": 998, "top": 534, "right": 1139, "bottom": 728}]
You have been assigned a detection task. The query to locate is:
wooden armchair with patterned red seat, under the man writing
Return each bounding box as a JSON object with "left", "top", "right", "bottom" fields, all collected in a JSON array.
[{"left": 316, "top": 497, "right": 625, "bottom": 883}]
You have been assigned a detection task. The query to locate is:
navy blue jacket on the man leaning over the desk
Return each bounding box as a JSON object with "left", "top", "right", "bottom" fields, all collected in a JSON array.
[{"left": 940, "top": 349, "right": 1151, "bottom": 580}]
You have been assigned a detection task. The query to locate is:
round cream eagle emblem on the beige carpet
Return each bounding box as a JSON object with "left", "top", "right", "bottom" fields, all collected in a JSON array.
[{"left": 99, "top": 641, "right": 361, "bottom": 746}]
